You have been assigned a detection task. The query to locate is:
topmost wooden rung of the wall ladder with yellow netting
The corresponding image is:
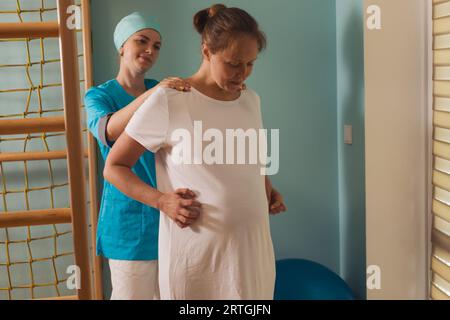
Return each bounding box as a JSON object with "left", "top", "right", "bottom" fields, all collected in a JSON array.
[{"left": 0, "top": 22, "right": 59, "bottom": 39}]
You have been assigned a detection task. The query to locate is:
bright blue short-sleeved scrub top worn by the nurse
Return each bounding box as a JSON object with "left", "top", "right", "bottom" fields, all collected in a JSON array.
[{"left": 84, "top": 79, "right": 159, "bottom": 260}]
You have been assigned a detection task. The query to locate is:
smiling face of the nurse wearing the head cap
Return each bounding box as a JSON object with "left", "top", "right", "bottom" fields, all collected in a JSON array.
[{"left": 120, "top": 29, "right": 161, "bottom": 73}]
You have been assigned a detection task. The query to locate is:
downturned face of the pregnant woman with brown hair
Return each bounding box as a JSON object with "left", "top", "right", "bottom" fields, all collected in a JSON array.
[{"left": 209, "top": 35, "right": 259, "bottom": 93}]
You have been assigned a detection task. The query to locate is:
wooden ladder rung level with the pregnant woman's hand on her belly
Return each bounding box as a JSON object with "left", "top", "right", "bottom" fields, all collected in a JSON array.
[{"left": 0, "top": 208, "right": 72, "bottom": 228}]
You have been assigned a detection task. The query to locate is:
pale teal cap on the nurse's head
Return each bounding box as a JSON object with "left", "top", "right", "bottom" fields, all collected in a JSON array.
[{"left": 114, "top": 12, "right": 161, "bottom": 51}]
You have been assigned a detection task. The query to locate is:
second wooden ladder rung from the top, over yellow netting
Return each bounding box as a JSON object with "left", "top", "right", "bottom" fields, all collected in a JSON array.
[{"left": 0, "top": 117, "right": 65, "bottom": 135}]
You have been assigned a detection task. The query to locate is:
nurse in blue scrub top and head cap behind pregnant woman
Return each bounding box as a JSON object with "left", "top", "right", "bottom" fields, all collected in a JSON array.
[{"left": 85, "top": 12, "right": 193, "bottom": 299}]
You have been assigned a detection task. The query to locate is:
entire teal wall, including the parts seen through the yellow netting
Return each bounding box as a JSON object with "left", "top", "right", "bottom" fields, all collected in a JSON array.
[{"left": 0, "top": 0, "right": 365, "bottom": 299}]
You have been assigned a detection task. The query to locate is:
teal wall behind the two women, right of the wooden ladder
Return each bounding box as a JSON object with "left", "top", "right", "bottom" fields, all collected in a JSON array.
[{"left": 92, "top": 0, "right": 365, "bottom": 297}]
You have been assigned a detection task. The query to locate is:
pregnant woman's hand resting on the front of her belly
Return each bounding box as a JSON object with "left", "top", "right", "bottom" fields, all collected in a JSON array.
[{"left": 158, "top": 188, "right": 202, "bottom": 228}]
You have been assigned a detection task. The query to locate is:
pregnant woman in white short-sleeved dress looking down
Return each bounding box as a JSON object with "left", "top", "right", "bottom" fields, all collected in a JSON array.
[{"left": 104, "top": 5, "right": 286, "bottom": 299}]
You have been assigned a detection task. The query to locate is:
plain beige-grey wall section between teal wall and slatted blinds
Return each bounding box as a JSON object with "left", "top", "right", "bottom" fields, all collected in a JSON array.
[{"left": 364, "top": 0, "right": 433, "bottom": 300}]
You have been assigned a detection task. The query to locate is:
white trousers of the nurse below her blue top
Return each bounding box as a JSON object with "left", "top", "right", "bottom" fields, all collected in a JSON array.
[{"left": 109, "top": 259, "right": 159, "bottom": 300}]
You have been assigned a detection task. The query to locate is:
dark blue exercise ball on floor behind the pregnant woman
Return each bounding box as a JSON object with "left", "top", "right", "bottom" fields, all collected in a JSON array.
[{"left": 274, "top": 259, "right": 355, "bottom": 300}]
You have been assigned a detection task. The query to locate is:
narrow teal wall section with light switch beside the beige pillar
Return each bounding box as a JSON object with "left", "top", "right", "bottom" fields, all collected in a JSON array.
[{"left": 336, "top": 0, "right": 366, "bottom": 298}]
